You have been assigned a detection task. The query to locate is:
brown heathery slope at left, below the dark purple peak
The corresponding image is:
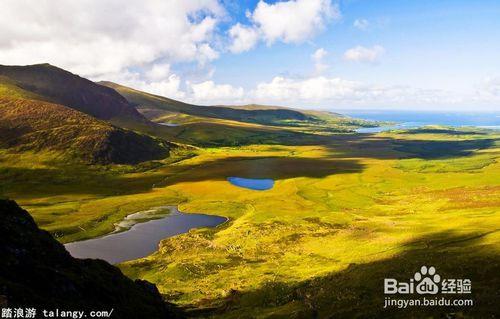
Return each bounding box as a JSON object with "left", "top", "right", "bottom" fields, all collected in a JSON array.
[{"left": 0, "top": 97, "right": 169, "bottom": 164}]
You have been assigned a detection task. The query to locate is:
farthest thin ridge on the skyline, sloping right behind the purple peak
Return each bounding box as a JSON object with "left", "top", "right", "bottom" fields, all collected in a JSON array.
[{"left": 99, "top": 81, "right": 317, "bottom": 125}]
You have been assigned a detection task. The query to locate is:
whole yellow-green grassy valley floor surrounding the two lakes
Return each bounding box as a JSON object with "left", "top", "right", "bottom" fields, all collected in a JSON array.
[{"left": 0, "top": 128, "right": 500, "bottom": 318}]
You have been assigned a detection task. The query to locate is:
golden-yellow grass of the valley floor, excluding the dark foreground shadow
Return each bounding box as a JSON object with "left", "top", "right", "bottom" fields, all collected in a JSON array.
[{"left": 3, "top": 128, "right": 500, "bottom": 317}]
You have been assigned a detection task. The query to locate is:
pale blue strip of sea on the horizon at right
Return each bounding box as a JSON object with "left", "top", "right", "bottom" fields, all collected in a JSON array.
[{"left": 343, "top": 110, "right": 500, "bottom": 133}]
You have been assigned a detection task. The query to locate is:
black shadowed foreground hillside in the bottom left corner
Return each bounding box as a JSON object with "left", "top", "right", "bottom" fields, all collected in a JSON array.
[{"left": 0, "top": 200, "right": 179, "bottom": 318}]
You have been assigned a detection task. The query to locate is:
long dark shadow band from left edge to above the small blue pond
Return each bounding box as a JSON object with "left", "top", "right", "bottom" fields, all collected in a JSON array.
[{"left": 0, "top": 156, "right": 365, "bottom": 199}]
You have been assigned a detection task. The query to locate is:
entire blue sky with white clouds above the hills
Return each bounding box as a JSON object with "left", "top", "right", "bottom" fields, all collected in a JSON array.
[{"left": 0, "top": 0, "right": 500, "bottom": 112}]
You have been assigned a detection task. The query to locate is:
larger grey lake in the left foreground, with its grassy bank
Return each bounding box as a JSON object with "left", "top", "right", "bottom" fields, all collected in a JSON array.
[{"left": 64, "top": 206, "right": 227, "bottom": 264}]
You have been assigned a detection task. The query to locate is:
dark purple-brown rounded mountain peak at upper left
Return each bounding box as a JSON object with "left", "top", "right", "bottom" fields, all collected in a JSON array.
[{"left": 0, "top": 64, "right": 146, "bottom": 121}]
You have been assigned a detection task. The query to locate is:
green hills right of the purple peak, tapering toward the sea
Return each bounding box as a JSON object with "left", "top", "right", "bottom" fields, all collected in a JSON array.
[{"left": 100, "top": 82, "right": 378, "bottom": 146}]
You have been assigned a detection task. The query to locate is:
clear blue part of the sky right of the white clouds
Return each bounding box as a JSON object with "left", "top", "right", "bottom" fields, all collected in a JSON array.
[{"left": 210, "top": 0, "right": 500, "bottom": 109}]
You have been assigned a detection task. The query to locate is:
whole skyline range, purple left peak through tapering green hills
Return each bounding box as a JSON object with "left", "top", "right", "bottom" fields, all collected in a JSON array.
[{"left": 0, "top": 64, "right": 376, "bottom": 151}]
